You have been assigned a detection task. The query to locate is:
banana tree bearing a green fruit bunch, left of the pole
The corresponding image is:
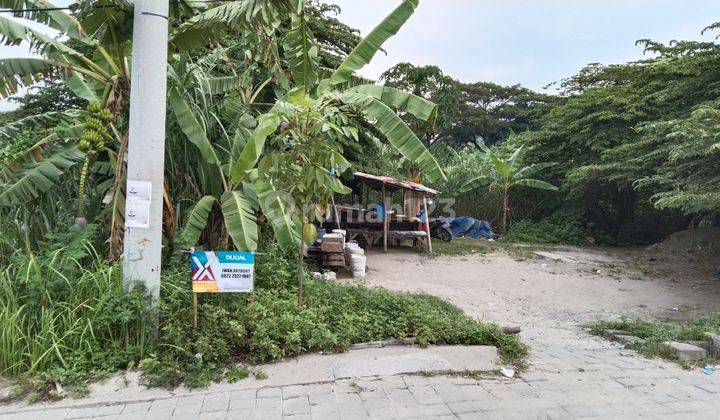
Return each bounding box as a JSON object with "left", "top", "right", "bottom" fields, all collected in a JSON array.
[{"left": 0, "top": 0, "right": 214, "bottom": 254}]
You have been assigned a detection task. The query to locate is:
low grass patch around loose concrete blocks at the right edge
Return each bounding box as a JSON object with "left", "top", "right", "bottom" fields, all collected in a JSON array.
[{"left": 589, "top": 313, "right": 720, "bottom": 367}]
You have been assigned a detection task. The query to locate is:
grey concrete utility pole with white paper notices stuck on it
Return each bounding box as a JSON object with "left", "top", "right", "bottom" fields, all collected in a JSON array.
[{"left": 123, "top": 0, "right": 169, "bottom": 299}]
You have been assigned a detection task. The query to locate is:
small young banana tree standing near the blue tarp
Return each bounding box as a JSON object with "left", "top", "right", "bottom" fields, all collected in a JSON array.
[{"left": 460, "top": 142, "right": 558, "bottom": 233}]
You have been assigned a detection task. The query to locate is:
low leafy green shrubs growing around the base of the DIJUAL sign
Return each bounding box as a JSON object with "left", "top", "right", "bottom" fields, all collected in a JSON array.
[{"left": 142, "top": 246, "right": 524, "bottom": 387}]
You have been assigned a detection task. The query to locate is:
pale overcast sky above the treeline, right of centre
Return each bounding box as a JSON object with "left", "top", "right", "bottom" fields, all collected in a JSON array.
[{"left": 333, "top": 0, "right": 720, "bottom": 90}]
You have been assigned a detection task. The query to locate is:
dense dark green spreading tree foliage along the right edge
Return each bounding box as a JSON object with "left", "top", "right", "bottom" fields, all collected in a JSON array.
[{"left": 511, "top": 33, "right": 720, "bottom": 243}]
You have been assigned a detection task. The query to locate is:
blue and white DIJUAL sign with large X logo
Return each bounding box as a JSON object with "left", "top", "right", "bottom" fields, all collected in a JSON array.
[{"left": 190, "top": 251, "right": 255, "bottom": 293}]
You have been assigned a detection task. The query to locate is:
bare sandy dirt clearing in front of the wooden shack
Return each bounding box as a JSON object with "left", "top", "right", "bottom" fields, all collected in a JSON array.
[{"left": 366, "top": 244, "right": 720, "bottom": 330}]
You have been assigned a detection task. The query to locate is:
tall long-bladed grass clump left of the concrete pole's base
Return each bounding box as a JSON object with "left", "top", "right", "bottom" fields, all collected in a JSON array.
[{"left": 0, "top": 223, "right": 152, "bottom": 393}]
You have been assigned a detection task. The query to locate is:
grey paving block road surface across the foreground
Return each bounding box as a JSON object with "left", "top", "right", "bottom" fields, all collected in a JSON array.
[{"left": 0, "top": 331, "right": 720, "bottom": 420}]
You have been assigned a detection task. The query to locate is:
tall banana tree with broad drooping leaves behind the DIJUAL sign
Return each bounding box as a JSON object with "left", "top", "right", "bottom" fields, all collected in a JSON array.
[{"left": 170, "top": 0, "right": 444, "bottom": 302}]
